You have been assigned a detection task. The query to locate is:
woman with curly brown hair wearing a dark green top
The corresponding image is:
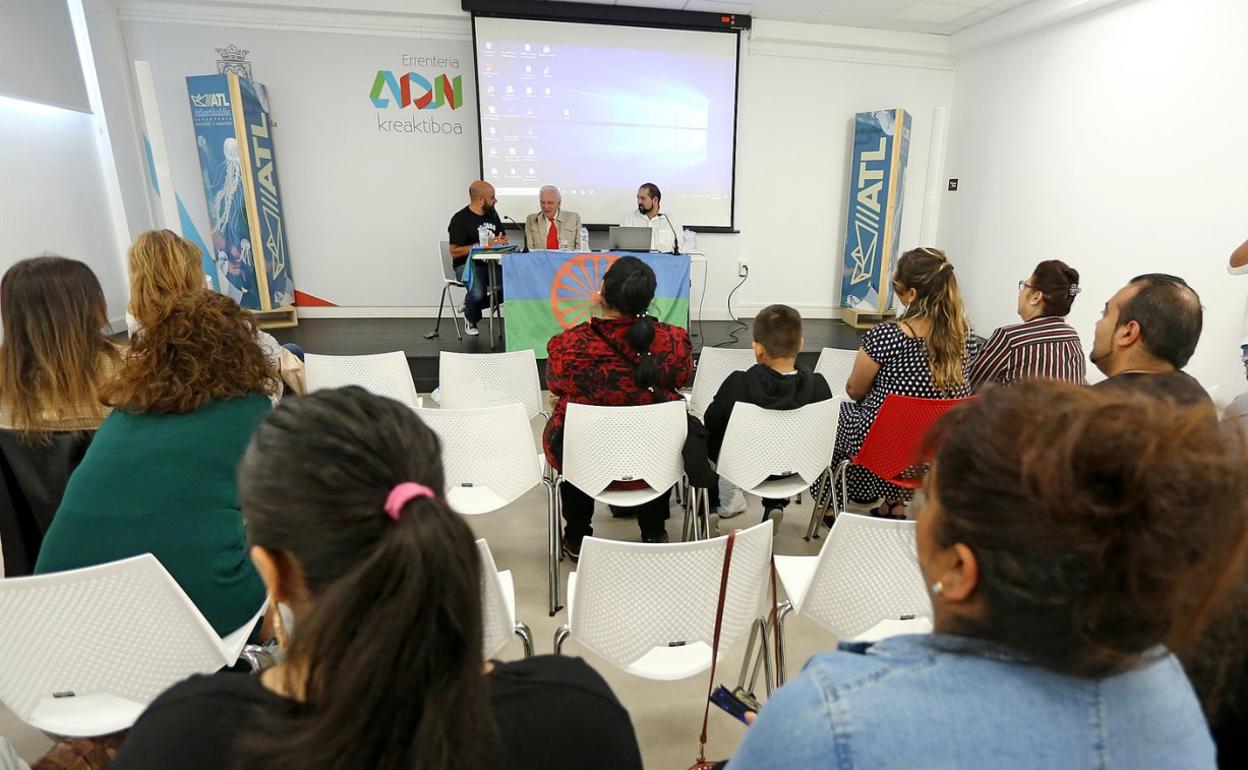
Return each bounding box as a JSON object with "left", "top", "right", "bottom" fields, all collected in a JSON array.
[{"left": 35, "top": 290, "right": 277, "bottom": 635}]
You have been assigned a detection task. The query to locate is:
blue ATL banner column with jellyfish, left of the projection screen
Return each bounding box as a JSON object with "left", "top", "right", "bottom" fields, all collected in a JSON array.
[{"left": 186, "top": 75, "right": 295, "bottom": 311}]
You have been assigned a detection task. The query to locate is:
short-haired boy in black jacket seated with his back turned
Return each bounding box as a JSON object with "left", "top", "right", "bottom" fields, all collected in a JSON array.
[{"left": 704, "top": 305, "right": 832, "bottom": 528}]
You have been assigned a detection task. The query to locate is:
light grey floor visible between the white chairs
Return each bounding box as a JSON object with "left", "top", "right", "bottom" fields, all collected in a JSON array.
[{"left": 0, "top": 416, "right": 848, "bottom": 770}]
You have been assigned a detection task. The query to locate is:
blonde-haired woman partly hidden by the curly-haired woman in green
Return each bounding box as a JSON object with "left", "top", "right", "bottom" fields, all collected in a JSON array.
[{"left": 126, "top": 230, "right": 303, "bottom": 393}]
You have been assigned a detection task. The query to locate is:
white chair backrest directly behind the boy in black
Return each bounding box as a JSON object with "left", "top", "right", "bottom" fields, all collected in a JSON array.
[{"left": 716, "top": 398, "right": 842, "bottom": 490}]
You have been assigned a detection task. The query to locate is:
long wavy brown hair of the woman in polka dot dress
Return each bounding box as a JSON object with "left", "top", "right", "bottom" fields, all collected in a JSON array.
[{"left": 897, "top": 248, "right": 971, "bottom": 393}]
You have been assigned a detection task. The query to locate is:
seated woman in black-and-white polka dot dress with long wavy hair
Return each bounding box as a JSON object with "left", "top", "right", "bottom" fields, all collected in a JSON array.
[{"left": 832, "top": 248, "right": 978, "bottom": 518}]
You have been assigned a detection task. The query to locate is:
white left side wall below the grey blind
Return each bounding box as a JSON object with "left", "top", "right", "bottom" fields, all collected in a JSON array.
[{"left": 0, "top": 97, "right": 127, "bottom": 319}]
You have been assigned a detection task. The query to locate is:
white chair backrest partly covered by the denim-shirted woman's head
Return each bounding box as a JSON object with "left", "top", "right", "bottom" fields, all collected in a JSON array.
[{"left": 795, "top": 513, "right": 932, "bottom": 639}]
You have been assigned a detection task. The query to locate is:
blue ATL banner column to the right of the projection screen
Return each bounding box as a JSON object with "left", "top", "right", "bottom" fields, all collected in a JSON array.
[{"left": 841, "top": 110, "right": 910, "bottom": 313}]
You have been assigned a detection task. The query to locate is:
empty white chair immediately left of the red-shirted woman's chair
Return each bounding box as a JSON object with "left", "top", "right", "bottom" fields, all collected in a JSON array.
[{"left": 416, "top": 403, "right": 559, "bottom": 615}]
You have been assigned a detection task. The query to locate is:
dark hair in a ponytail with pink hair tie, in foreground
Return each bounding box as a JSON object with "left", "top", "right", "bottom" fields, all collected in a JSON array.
[{"left": 238, "top": 388, "right": 498, "bottom": 770}]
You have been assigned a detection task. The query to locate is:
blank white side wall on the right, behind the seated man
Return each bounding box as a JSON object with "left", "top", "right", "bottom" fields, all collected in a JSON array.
[{"left": 940, "top": 0, "right": 1248, "bottom": 397}]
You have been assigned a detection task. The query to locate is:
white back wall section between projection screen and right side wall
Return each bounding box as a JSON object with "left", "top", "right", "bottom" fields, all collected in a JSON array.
[{"left": 728, "top": 21, "right": 953, "bottom": 318}]
